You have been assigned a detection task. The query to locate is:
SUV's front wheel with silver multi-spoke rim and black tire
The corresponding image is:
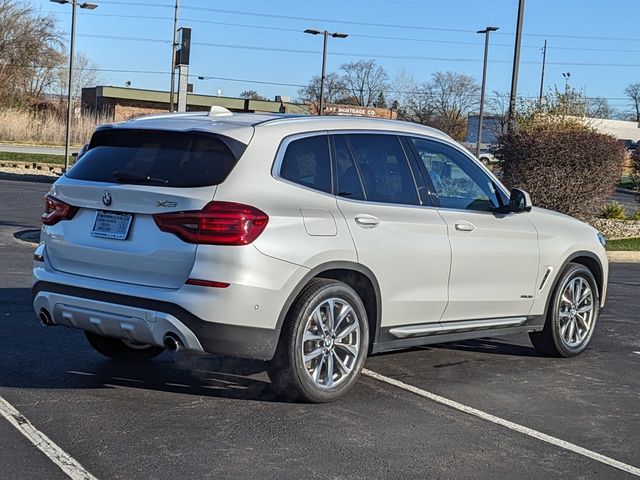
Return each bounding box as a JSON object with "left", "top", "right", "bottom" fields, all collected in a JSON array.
[{"left": 529, "top": 263, "right": 600, "bottom": 357}]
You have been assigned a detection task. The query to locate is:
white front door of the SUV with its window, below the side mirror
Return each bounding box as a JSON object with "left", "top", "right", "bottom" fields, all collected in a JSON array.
[{"left": 410, "top": 137, "right": 539, "bottom": 322}]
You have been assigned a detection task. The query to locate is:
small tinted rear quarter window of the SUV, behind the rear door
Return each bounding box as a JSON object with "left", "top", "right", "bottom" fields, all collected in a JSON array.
[{"left": 280, "top": 135, "right": 332, "bottom": 193}]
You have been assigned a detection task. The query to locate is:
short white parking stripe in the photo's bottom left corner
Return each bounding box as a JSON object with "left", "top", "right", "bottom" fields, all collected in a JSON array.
[{"left": 0, "top": 397, "right": 96, "bottom": 480}]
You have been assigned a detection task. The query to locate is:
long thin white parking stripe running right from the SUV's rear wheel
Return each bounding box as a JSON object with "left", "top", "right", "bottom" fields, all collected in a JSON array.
[{"left": 362, "top": 368, "right": 640, "bottom": 477}]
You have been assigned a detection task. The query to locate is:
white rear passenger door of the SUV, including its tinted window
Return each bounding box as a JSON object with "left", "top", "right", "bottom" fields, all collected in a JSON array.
[{"left": 330, "top": 133, "right": 451, "bottom": 333}]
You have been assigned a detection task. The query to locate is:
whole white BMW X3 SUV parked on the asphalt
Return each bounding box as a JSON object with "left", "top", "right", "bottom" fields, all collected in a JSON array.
[{"left": 33, "top": 107, "right": 608, "bottom": 402}]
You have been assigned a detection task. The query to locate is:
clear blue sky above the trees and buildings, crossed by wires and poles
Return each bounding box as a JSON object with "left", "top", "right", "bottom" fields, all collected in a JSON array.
[{"left": 37, "top": 0, "right": 640, "bottom": 109}]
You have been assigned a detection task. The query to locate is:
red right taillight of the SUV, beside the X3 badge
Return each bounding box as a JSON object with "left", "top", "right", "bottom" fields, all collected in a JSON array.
[{"left": 153, "top": 201, "right": 269, "bottom": 245}]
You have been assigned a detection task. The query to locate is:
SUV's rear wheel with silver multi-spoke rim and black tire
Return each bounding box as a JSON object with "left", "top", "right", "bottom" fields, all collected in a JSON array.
[{"left": 267, "top": 279, "right": 369, "bottom": 403}]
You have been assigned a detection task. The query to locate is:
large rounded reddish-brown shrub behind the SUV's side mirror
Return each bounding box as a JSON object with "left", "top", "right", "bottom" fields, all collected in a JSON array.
[{"left": 495, "top": 119, "right": 626, "bottom": 216}]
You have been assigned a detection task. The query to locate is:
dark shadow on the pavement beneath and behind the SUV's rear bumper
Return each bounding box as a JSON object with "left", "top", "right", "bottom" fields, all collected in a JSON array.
[{"left": 0, "top": 288, "right": 286, "bottom": 402}]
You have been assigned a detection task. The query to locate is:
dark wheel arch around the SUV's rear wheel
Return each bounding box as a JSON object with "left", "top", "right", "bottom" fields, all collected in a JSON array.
[{"left": 277, "top": 261, "right": 382, "bottom": 348}]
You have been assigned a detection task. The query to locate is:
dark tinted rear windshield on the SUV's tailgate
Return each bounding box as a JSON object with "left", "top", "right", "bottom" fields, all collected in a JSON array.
[{"left": 67, "top": 129, "right": 246, "bottom": 187}]
